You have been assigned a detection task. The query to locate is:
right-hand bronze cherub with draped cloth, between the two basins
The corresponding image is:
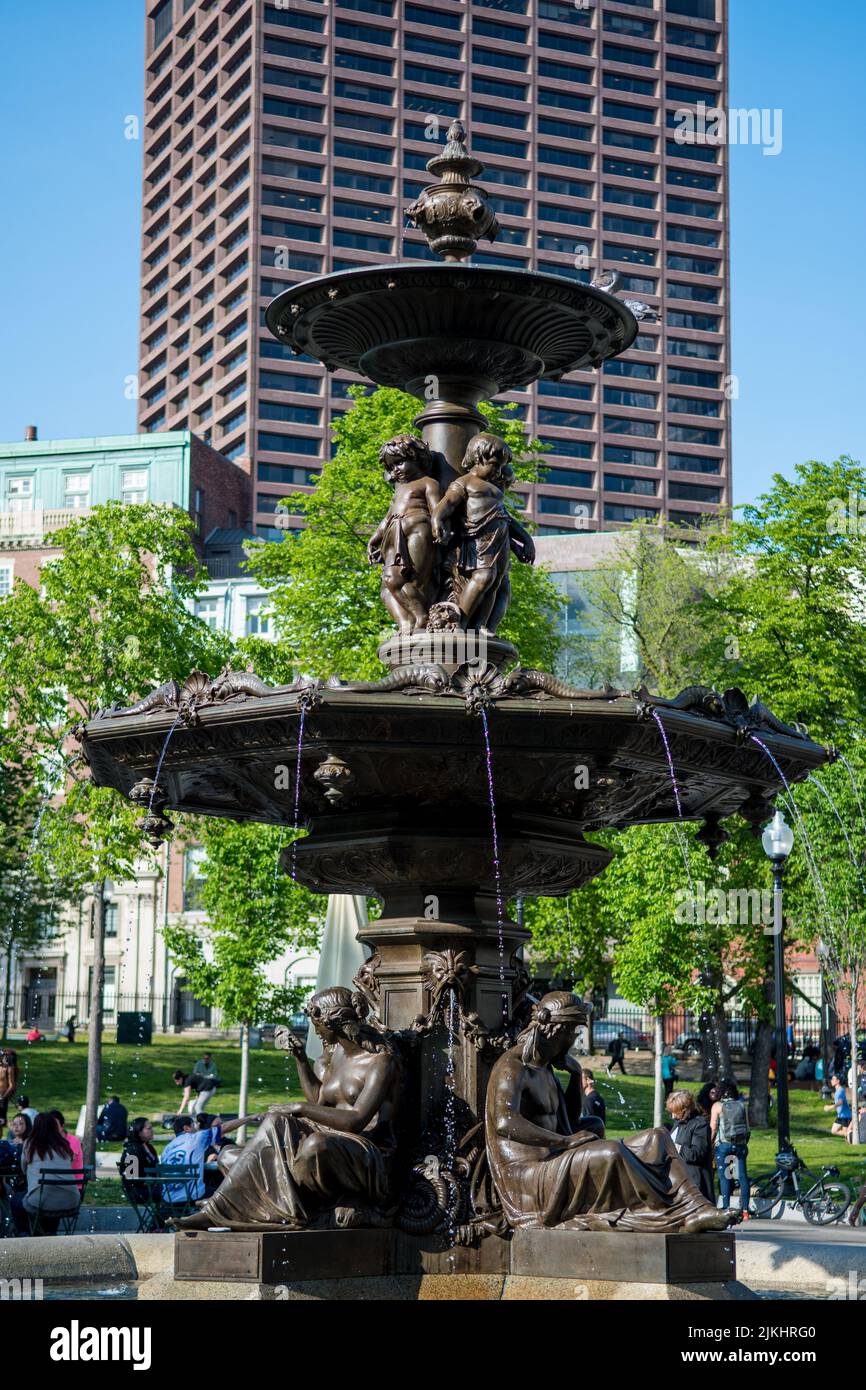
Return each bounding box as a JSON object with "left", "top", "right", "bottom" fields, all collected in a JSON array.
[{"left": 432, "top": 434, "right": 535, "bottom": 635}]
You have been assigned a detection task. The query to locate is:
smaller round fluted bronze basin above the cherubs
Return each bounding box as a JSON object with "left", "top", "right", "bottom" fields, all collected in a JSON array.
[{"left": 265, "top": 261, "right": 638, "bottom": 398}]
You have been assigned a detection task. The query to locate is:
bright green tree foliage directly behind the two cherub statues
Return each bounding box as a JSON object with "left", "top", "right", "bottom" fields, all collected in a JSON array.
[{"left": 249, "top": 388, "right": 562, "bottom": 680}]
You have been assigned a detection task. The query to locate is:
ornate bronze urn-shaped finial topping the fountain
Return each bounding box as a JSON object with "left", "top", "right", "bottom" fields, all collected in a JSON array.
[{"left": 406, "top": 121, "right": 499, "bottom": 261}]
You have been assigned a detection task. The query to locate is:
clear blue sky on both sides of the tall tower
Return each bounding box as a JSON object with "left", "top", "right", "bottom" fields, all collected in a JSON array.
[{"left": 0, "top": 0, "right": 866, "bottom": 503}]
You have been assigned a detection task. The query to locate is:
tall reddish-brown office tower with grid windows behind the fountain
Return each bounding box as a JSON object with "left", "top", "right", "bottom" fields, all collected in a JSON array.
[{"left": 139, "top": 0, "right": 731, "bottom": 534}]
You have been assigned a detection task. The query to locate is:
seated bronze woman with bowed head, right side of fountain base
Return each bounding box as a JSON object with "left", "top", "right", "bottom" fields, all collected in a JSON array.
[{"left": 487, "top": 991, "right": 730, "bottom": 1233}]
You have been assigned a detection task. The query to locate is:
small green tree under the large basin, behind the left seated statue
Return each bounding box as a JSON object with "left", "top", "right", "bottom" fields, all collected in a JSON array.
[{"left": 163, "top": 819, "right": 324, "bottom": 1143}]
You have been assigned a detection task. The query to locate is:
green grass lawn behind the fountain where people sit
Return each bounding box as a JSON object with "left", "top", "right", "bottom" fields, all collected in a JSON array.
[{"left": 15, "top": 1036, "right": 866, "bottom": 1204}]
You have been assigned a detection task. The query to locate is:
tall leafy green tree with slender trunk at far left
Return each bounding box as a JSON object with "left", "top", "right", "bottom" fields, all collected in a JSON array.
[{"left": 0, "top": 502, "right": 231, "bottom": 1163}]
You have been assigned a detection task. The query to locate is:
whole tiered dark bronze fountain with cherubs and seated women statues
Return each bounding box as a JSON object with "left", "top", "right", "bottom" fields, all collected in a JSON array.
[{"left": 83, "top": 122, "right": 828, "bottom": 1297}]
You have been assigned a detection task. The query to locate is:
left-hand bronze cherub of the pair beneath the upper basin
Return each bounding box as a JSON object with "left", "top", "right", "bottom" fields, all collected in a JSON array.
[{"left": 367, "top": 434, "right": 442, "bottom": 632}]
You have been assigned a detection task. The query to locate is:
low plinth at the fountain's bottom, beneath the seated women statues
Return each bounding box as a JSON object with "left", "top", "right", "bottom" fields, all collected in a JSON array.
[{"left": 174, "top": 1229, "right": 752, "bottom": 1301}]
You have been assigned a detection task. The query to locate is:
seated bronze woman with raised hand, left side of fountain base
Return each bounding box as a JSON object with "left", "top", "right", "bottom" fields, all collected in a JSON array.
[{"left": 181, "top": 987, "right": 403, "bottom": 1230}]
